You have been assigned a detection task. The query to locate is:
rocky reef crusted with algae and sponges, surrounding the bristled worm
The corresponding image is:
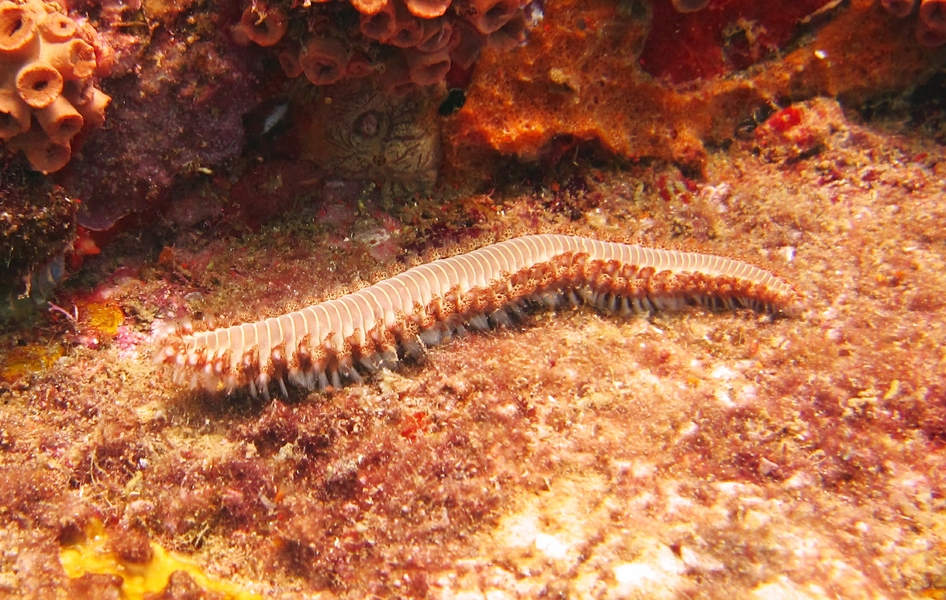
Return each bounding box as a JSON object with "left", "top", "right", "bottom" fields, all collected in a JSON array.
[{"left": 0, "top": 0, "right": 946, "bottom": 599}]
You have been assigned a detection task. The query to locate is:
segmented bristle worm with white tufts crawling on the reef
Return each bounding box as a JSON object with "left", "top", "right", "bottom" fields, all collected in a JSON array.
[{"left": 155, "top": 234, "right": 796, "bottom": 399}]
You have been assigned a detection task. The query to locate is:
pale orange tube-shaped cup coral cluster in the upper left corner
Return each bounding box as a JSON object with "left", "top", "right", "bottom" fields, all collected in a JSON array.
[{"left": 0, "top": 0, "right": 111, "bottom": 173}]
